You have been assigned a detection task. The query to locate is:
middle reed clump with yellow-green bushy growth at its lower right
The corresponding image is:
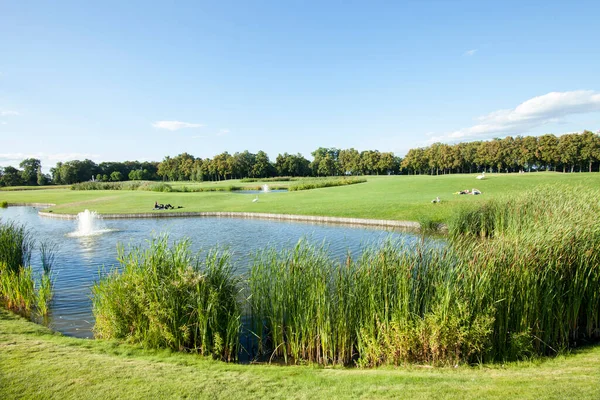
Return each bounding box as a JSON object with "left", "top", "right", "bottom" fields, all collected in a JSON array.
[{"left": 249, "top": 242, "right": 493, "bottom": 367}]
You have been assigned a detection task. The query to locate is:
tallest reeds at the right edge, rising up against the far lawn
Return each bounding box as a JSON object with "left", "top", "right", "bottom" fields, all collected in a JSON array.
[{"left": 449, "top": 187, "right": 600, "bottom": 359}]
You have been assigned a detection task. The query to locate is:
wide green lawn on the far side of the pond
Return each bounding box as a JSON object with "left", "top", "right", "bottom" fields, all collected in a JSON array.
[{"left": 0, "top": 172, "right": 600, "bottom": 221}]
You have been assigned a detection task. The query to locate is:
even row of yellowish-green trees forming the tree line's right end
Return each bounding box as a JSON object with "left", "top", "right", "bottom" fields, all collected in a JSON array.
[{"left": 401, "top": 131, "right": 600, "bottom": 175}]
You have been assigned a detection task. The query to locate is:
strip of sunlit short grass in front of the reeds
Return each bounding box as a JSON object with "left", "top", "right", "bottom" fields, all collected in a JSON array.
[{"left": 0, "top": 309, "right": 600, "bottom": 399}]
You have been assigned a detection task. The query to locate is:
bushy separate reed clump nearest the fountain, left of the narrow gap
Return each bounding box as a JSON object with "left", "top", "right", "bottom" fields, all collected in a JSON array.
[{"left": 92, "top": 236, "right": 241, "bottom": 361}]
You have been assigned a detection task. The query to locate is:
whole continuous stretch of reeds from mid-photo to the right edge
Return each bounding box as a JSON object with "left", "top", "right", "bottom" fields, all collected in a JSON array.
[{"left": 249, "top": 187, "right": 600, "bottom": 367}]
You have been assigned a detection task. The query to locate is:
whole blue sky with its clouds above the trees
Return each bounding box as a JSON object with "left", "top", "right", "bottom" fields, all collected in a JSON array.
[{"left": 0, "top": 0, "right": 600, "bottom": 171}]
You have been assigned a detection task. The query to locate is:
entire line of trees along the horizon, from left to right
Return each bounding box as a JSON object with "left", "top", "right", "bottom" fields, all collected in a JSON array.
[{"left": 0, "top": 131, "right": 600, "bottom": 186}]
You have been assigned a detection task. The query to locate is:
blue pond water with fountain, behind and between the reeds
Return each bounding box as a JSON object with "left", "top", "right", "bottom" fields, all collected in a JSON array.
[{"left": 0, "top": 207, "right": 421, "bottom": 338}]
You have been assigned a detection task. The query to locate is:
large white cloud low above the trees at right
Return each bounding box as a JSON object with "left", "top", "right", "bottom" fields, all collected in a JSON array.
[{"left": 430, "top": 90, "right": 600, "bottom": 143}]
